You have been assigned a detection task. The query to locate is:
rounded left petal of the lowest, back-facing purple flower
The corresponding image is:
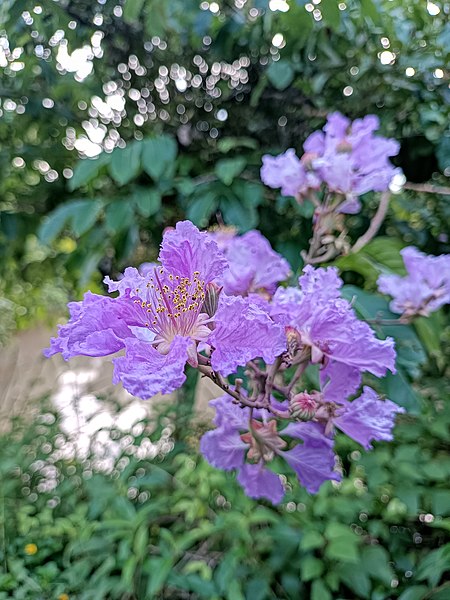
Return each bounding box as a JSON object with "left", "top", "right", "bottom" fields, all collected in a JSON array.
[{"left": 200, "top": 427, "right": 249, "bottom": 471}]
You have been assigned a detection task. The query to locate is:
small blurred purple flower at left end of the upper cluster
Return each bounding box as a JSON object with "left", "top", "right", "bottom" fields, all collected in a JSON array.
[{"left": 261, "top": 148, "right": 320, "bottom": 197}]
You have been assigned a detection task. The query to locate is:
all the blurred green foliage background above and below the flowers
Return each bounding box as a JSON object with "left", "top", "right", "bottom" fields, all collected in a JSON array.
[{"left": 0, "top": 0, "right": 450, "bottom": 600}]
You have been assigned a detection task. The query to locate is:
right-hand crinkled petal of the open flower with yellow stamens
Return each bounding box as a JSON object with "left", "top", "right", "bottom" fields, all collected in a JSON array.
[{"left": 208, "top": 296, "right": 286, "bottom": 376}]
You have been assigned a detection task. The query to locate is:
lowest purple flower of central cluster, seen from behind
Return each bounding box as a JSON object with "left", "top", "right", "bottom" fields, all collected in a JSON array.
[{"left": 200, "top": 395, "right": 339, "bottom": 504}]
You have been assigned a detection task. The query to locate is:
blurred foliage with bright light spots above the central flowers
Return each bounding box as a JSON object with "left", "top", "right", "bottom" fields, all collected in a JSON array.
[{"left": 0, "top": 0, "right": 450, "bottom": 338}]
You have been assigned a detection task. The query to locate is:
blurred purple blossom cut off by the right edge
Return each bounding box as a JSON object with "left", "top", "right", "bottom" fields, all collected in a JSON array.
[{"left": 378, "top": 246, "right": 450, "bottom": 318}]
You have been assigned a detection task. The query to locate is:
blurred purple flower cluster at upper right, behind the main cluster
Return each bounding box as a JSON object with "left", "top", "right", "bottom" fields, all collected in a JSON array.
[{"left": 261, "top": 112, "right": 400, "bottom": 213}]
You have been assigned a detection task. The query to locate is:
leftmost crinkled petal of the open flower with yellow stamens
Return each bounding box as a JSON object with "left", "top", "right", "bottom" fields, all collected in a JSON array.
[{"left": 44, "top": 292, "right": 134, "bottom": 360}]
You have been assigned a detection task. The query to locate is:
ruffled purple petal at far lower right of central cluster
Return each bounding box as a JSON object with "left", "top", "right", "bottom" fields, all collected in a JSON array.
[{"left": 334, "top": 387, "right": 405, "bottom": 450}]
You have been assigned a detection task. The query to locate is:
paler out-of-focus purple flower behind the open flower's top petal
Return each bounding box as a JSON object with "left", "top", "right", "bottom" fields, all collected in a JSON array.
[{"left": 210, "top": 230, "right": 291, "bottom": 296}]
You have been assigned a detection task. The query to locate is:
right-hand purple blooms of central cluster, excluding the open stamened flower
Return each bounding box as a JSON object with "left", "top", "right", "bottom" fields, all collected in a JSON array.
[{"left": 201, "top": 266, "right": 404, "bottom": 503}]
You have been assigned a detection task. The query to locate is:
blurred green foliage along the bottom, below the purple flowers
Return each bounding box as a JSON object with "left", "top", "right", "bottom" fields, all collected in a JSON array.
[{"left": 0, "top": 352, "right": 450, "bottom": 600}]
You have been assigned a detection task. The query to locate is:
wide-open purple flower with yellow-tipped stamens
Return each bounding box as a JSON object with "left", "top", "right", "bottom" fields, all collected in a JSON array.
[{"left": 45, "top": 221, "right": 285, "bottom": 398}]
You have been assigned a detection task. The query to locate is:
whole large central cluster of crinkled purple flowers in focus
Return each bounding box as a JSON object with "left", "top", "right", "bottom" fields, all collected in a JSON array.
[{"left": 46, "top": 221, "right": 403, "bottom": 503}]
